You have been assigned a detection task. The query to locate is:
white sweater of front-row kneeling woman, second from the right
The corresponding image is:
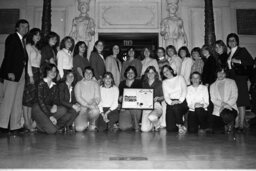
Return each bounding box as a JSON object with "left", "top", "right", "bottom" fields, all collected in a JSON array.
[{"left": 186, "top": 85, "right": 209, "bottom": 111}]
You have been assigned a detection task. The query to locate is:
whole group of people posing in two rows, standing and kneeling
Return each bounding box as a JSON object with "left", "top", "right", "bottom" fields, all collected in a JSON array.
[{"left": 0, "top": 20, "right": 254, "bottom": 134}]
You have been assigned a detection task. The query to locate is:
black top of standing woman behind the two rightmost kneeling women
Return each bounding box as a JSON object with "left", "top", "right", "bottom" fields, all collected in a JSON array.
[{"left": 202, "top": 56, "right": 217, "bottom": 85}]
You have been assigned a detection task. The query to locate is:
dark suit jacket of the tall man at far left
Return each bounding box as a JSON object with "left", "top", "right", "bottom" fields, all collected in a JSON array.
[{"left": 0, "top": 33, "right": 28, "bottom": 82}]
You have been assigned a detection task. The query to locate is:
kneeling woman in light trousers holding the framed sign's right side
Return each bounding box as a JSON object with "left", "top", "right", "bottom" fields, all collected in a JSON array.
[{"left": 141, "top": 66, "right": 164, "bottom": 132}]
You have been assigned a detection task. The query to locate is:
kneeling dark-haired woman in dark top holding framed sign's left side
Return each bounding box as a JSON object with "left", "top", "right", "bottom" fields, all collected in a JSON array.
[{"left": 119, "top": 66, "right": 141, "bottom": 131}]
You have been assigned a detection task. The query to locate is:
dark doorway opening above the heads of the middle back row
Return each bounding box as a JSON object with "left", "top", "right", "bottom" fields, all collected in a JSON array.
[{"left": 99, "top": 33, "right": 158, "bottom": 61}]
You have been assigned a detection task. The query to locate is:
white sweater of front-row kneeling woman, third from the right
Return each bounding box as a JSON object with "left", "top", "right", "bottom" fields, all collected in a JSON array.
[{"left": 162, "top": 75, "right": 187, "bottom": 105}]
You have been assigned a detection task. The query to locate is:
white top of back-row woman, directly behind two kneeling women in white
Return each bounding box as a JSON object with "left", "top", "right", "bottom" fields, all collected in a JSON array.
[{"left": 180, "top": 58, "right": 194, "bottom": 85}]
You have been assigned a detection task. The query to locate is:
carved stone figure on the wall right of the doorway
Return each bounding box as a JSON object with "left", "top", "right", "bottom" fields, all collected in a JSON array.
[{"left": 160, "top": 0, "right": 187, "bottom": 50}]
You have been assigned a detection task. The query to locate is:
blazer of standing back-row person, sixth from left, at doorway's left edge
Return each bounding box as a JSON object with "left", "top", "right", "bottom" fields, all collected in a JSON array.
[{"left": 90, "top": 52, "right": 106, "bottom": 80}]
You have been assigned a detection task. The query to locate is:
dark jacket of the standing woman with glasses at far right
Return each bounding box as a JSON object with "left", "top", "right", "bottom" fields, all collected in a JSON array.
[{"left": 232, "top": 47, "right": 254, "bottom": 75}]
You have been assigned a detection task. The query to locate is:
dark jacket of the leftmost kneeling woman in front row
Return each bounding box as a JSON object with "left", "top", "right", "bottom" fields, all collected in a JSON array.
[{"left": 37, "top": 80, "right": 59, "bottom": 116}]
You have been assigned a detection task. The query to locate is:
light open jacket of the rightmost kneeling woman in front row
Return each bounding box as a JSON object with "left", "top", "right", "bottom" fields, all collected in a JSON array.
[{"left": 210, "top": 78, "right": 238, "bottom": 116}]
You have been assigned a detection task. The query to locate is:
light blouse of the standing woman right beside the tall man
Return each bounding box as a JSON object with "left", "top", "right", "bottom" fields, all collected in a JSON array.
[{"left": 26, "top": 44, "right": 41, "bottom": 77}]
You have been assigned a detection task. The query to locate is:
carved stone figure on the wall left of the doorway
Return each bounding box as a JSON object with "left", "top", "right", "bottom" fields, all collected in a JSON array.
[{"left": 69, "top": 0, "right": 95, "bottom": 46}]
